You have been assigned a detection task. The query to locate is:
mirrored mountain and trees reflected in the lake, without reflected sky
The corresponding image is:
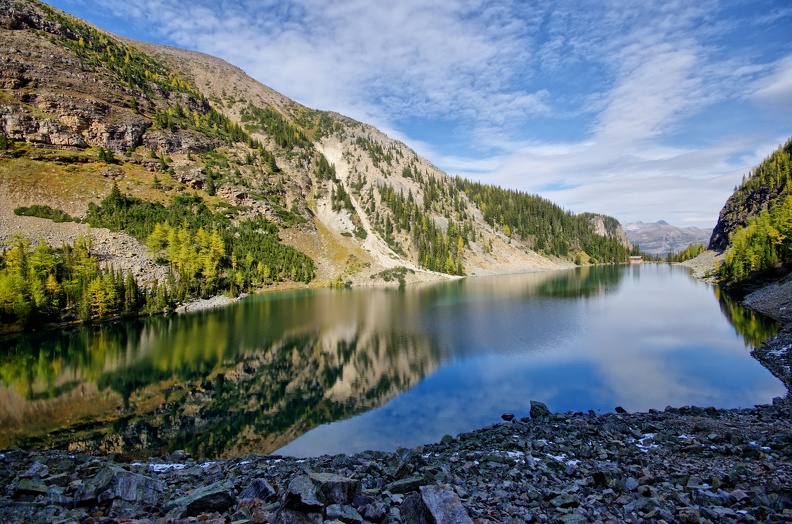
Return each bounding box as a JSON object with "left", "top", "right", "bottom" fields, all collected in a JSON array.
[{"left": 0, "top": 266, "right": 776, "bottom": 457}]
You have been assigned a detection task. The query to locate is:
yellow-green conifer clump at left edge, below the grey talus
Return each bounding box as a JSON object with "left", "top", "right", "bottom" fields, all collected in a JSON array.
[{"left": 0, "top": 235, "right": 162, "bottom": 328}]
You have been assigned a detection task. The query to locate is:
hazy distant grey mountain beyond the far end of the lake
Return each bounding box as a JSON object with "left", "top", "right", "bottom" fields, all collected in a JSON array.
[{"left": 624, "top": 220, "right": 712, "bottom": 256}]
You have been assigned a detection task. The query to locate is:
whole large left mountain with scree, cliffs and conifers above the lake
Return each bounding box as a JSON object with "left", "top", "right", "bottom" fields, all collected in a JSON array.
[{"left": 0, "top": 0, "right": 627, "bottom": 324}]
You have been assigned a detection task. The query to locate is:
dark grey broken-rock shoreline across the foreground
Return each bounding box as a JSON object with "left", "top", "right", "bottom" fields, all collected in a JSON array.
[{"left": 0, "top": 268, "right": 792, "bottom": 524}]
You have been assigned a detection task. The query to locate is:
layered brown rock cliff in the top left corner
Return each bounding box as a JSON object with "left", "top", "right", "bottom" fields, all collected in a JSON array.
[{"left": 0, "top": 4, "right": 151, "bottom": 153}]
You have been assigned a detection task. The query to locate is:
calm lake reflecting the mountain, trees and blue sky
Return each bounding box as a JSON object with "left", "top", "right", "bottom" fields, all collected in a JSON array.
[{"left": 0, "top": 264, "right": 785, "bottom": 457}]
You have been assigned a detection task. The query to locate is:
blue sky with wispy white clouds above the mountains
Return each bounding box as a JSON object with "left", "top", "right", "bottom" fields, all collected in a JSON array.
[{"left": 51, "top": 0, "right": 792, "bottom": 227}]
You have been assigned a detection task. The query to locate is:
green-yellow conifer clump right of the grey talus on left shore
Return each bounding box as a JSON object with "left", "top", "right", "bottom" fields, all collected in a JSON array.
[{"left": 86, "top": 185, "right": 315, "bottom": 300}]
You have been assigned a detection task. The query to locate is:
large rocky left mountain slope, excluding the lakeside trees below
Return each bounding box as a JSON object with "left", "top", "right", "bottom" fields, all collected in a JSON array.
[{"left": 0, "top": 0, "right": 623, "bottom": 294}]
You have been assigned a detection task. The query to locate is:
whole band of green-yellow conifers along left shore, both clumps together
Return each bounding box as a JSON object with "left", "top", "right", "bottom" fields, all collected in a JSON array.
[{"left": 0, "top": 182, "right": 314, "bottom": 328}]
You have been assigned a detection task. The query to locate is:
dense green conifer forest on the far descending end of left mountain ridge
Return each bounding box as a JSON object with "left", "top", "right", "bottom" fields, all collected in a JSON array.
[{"left": 456, "top": 177, "right": 630, "bottom": 263}]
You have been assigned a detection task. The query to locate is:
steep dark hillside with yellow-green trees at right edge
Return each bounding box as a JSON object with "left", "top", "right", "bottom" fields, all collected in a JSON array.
[{"left": 710, "top": 139, "right": 792, "bottom": 284}]
